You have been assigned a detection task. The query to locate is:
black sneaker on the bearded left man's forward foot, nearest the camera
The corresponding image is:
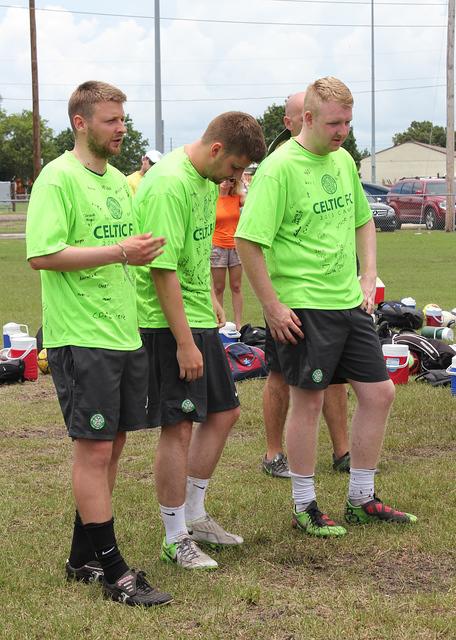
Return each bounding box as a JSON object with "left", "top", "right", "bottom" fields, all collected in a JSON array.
[{"left": 103, "top": 569, "right": 173, "bottom": 607}]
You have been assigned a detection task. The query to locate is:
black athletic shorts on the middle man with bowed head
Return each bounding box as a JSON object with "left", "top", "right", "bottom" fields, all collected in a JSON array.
[{"left": 140, "top": 329, "right": 239, "bottom": 427}]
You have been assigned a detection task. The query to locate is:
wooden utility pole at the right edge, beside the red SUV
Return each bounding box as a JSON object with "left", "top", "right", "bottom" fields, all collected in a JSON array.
[{"left": 445, "top": 0, "right": 455, "bottom": 231}]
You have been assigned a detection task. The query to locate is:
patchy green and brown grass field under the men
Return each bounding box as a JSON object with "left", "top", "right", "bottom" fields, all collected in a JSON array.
[{"left": 0, "top": 231, "right": 456, "bottom": 640}]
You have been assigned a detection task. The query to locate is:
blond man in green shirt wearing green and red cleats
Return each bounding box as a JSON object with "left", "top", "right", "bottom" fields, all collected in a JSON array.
[{"left": 236, "top": 77, "right": 416, "bottom": 537}]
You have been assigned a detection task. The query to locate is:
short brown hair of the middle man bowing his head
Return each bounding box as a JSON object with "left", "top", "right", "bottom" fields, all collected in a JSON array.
[{"left": 201, "top": 111, "right": 266, "bottom": 162}]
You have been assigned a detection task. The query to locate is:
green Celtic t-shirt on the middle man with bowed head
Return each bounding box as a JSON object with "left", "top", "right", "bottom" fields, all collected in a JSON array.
[{"left": 134, "top": 147, "right": 218, "bottom": 329}]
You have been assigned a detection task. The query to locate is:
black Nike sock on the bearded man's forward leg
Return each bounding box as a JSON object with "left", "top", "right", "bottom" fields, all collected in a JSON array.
[{"left": 84, "top": 518, "right": 129, "bottom": 584}]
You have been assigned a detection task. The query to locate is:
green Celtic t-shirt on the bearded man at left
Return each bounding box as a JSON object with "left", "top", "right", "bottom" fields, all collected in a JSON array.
[{"left": 27, "top": 151, "right": 141, "bottom": 351}]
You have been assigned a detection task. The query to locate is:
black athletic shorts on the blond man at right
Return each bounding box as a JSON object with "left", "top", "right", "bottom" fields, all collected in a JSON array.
[{"left": 265, "top": 307, "right": 389, "bottom": 390}]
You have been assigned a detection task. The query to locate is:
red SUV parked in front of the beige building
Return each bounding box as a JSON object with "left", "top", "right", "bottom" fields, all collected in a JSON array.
[{"left": 386, "top": 178, "right": 447, "bottom": 231}]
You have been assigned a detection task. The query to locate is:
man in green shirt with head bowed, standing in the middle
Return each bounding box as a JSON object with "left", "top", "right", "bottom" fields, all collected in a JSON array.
[{"left": 134, "top": 112, "right": 266, "bottom": 569}]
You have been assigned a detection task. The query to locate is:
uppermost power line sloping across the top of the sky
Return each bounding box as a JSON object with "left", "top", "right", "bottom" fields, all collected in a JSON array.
[{"left": 0, "top": 3, "right": 446, "bottom": 29}]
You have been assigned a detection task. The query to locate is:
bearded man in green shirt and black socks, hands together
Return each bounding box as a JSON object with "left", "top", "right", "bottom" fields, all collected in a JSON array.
[{"left": 27, "top": 81, "right": 172, "bottom": 606}]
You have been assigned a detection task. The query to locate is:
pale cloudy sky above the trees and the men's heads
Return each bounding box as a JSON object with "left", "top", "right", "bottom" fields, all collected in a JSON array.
[{"left": 0, "top": 0, "right": 447, "bottom": 158}]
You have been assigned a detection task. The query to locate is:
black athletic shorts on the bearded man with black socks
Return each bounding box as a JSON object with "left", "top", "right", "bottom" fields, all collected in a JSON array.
[{"left": 47, "top": 346, "right": 151, "bottom": 440}]
